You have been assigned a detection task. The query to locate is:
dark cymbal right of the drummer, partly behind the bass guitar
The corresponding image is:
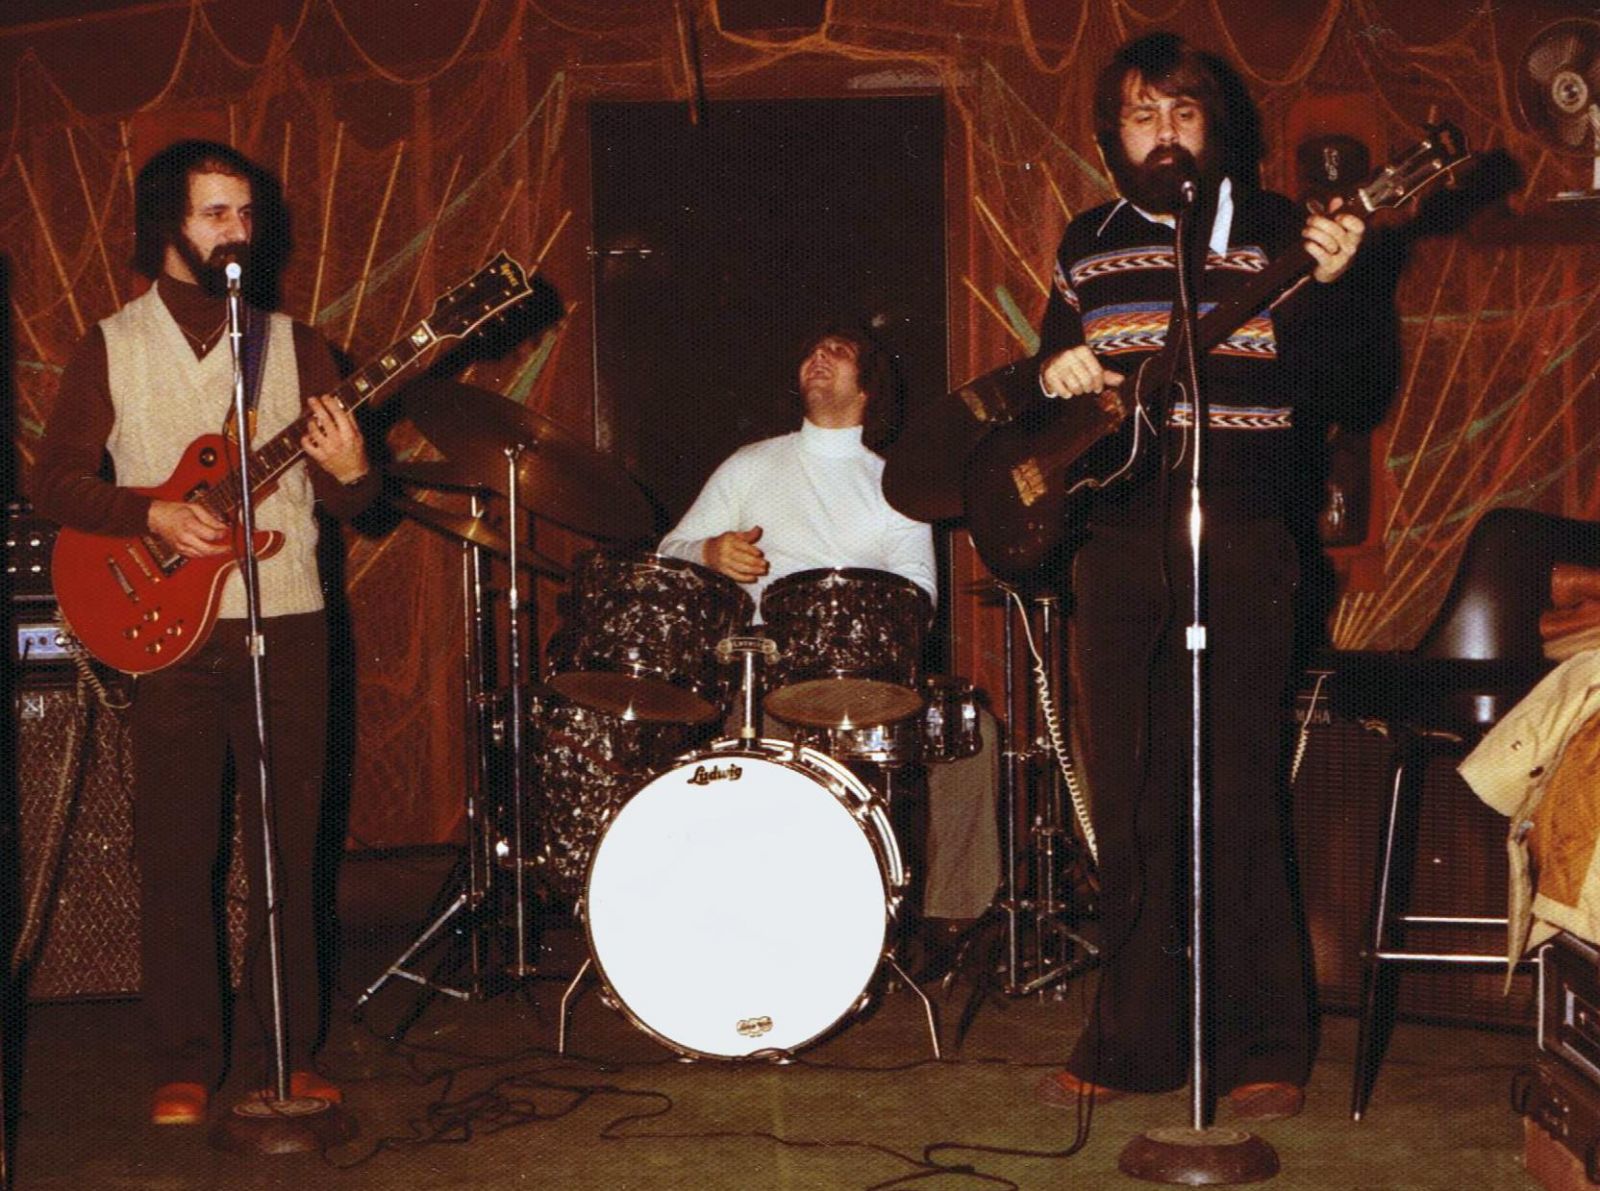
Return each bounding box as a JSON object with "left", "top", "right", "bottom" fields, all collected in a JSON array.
[{"left": 883, "top": 360, "right": 1034, "bottom": 522}]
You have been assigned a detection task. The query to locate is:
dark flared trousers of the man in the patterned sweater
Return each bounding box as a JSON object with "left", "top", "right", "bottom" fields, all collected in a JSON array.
[{"left": 1069, "top": 520, "right": 1312, "bottom": 1092}]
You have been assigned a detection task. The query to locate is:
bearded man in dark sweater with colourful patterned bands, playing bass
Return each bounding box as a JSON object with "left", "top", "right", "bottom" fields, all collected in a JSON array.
[{"left": 1037, "top": 34, "right": 1389, "bottom": 1119}]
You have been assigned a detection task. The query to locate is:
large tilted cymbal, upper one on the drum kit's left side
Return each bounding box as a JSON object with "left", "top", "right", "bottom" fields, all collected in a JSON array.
[{"left": 402, "top": 379, "right": 654, "bottom": 541}]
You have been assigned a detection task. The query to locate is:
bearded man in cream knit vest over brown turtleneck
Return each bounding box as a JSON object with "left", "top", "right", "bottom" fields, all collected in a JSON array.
[{"left": 30, "top": 141, "right": 379, "bottom": 1124}]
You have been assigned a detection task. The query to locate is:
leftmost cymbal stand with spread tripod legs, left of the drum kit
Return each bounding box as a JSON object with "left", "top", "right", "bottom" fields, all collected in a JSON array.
[{"left": 355, "top": 493, "right": 494, "bottom": 1011}]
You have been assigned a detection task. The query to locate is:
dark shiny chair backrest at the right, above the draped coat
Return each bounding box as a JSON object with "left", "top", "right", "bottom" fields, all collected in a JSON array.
[{"left": 1416, "top": 509, "right": 1600, "bottom": 661}]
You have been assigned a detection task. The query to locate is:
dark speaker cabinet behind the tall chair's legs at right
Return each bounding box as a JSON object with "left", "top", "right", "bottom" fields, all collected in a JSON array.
[{"left": 1294, "top": 719, "right": 1538, "bottom": 1026}]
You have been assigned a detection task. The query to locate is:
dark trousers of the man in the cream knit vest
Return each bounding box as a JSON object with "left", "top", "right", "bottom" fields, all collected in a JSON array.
[{"left": 130, "top": 612, "right": 328, "bottom": 1085}]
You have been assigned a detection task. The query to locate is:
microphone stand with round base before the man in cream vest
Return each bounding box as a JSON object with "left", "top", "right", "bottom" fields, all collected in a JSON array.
[{"left": 211, "top": 261, "right": 354, "bottom": 1154}]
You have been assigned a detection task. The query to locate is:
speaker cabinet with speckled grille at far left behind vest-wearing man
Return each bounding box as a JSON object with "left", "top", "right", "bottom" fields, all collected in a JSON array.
[{"left": 16, "top": 687, "right": 246, "bottom": 1001}]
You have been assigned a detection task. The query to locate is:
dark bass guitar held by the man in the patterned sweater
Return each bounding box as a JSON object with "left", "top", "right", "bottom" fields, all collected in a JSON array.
[{"left": 962, "top": 123, "right": 1467, "bottom": 584}]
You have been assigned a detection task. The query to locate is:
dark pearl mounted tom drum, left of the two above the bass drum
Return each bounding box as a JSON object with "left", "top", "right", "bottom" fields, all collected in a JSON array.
[{"left": 549, "top": 551, "right": 755, "bottom": 724}]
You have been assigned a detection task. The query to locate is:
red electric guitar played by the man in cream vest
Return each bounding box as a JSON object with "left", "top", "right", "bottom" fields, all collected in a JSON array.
[{"left": 50, "top": 253, "right": 531, "bottom": 674}]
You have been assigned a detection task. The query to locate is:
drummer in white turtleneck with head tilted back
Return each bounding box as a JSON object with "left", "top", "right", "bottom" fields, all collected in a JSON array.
[{"left": 661, "top": 324, "right": 936, "bottom": 605}]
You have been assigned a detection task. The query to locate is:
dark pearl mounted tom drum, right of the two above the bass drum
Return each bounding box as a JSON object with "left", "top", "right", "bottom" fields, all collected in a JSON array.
[{"left": 762, "top": 568, "right": 933, "bottom": 728}]
